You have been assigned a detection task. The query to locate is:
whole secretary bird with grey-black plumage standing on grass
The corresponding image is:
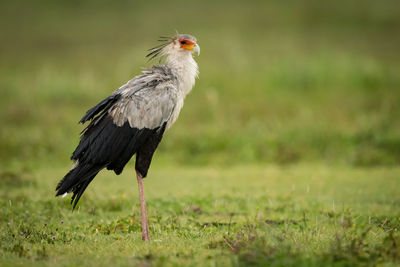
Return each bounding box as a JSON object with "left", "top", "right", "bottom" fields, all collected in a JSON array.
[{"left": 56, "top": 34, "right": 200, "bottom": 241}]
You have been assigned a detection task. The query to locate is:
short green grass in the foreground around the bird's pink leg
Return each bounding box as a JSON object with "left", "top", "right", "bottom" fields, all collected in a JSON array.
[{"left": 0, "top": 165, "right": 400, "bottom": 266}]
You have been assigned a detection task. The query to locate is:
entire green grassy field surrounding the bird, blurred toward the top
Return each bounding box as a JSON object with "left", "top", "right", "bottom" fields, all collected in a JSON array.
[{"left": 0, "top": 0, "right": 400, "bottom": 266}]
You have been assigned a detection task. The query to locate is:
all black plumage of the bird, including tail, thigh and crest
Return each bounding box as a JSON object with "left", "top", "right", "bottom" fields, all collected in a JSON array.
[{"left": 56, "top": 70, "right": 172, "bottom": 209}]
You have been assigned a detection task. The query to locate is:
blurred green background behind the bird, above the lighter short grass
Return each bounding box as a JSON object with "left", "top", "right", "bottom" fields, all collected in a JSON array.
[{"left": 0, "top": 0, "right": 400, "bottom": 170}]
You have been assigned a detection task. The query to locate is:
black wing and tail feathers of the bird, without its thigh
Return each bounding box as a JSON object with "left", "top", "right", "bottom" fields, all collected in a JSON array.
[{"left": 56, "top": 115, "right": 161, "bottom": 208}]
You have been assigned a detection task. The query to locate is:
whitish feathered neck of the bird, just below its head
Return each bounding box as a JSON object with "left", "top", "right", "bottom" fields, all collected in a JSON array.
[{"left": 165, "top": 52, "right": 198, "bottom": 97}]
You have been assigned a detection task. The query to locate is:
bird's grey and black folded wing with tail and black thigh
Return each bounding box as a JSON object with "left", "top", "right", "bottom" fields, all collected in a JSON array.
[{"left": 56, "top": 76, "right": 178, "bottom": 208}]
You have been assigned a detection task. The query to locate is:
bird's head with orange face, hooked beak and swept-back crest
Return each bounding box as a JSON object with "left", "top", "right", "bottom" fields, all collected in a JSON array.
[{"left": 146, "top": 34, "right": 200, "bottom": 59}]
